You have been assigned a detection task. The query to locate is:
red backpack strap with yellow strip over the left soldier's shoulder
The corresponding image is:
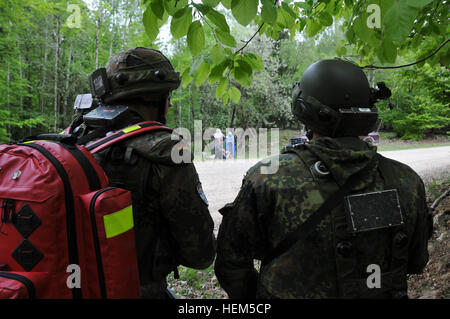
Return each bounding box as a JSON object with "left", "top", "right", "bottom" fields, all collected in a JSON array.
[{"left": 87, "top": 122, "right": 173, "bottom": 154}]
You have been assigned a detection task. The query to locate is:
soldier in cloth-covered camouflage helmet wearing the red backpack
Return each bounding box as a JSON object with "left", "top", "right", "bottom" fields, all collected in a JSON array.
[{"left": 71, "top": 47, "right": 215, "bottom": 299}]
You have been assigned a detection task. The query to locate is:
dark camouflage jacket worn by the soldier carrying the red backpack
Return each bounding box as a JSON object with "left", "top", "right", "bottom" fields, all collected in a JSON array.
[{"left": 89, "top": 112, "right": 216, "bottom": 299}]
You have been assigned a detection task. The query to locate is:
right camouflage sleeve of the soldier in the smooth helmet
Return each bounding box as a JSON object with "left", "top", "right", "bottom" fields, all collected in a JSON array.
[{"left": 408, "top": 180, "right": 433, "bottom": 274}]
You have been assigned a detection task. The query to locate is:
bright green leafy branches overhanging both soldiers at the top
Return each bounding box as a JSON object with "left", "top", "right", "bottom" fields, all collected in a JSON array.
[{"left": 143, "top": 0, "right": 450, "bottom": 101}]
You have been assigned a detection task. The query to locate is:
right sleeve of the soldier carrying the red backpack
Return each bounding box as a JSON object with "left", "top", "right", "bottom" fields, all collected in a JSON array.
[{"left": 154, "top": 164, "right": 216, "bottom": 269}]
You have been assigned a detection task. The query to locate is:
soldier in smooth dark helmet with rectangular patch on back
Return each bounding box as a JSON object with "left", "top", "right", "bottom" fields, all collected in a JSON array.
[{"left": 215, "top": 60, "right": 432, "bottom": 299}]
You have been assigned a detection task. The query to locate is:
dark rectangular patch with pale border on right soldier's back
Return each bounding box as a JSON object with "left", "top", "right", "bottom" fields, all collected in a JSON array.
[{"left": 344, "top": 189, "right": 403, "bottom": 233}]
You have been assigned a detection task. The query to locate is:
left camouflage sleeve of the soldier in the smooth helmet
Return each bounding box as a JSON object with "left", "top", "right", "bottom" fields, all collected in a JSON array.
[{"left": 215, "top": 180, "right": 268, "bottom": 299}]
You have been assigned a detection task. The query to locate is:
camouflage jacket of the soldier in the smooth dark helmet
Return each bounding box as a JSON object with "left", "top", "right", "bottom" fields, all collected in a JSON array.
[{"left": 215, "top": 138, "right": 431, "bottom": 299}]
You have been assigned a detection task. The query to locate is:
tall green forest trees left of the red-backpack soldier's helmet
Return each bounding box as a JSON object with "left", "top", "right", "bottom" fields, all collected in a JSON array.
[{"left": 0, "top": 0, "right": 150, "bottom": 142}]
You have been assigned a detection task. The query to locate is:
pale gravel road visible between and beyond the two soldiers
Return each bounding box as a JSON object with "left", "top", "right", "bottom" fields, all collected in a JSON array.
[{"left": 195, "top": 146, "right": 450, "bottom": 231}]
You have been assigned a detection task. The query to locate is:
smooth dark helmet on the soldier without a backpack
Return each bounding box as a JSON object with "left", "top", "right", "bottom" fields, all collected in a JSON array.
[{"left": 292, "top": 59, "right": 391, "bottom": 137}]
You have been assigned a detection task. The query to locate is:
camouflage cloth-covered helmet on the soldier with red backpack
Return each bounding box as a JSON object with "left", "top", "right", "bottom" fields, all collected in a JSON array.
[{"left": 104, "top": 47, "right": 181, "bottom": 103}]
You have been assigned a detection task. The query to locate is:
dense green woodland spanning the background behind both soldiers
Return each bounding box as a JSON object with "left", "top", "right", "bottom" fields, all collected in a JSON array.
[{"left": 0, "top": 0, "right": 450, "bottom": 142}]
